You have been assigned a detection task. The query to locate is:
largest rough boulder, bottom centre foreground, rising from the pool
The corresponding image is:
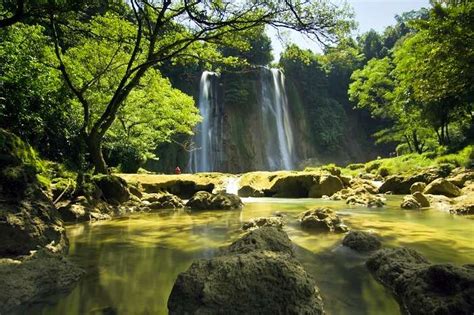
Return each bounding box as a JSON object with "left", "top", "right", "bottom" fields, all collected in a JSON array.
[{"left": 168, "top": 227, "right": 324, "bottom": 314}]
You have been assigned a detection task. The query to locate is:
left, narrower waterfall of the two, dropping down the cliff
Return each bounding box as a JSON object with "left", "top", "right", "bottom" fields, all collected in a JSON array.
[{"left": 189, "top": 71, "right": 220, "bottom": 172}]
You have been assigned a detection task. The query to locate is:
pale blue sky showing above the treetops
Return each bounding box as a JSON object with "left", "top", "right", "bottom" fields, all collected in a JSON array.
[{"left": 268, "top": 0, "right": 430, "bottom": 60}]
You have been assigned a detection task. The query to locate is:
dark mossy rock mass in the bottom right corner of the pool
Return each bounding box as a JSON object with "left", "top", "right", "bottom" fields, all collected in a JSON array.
[{"left": 367, "top": 248, "right": 474, "bottom": 315}]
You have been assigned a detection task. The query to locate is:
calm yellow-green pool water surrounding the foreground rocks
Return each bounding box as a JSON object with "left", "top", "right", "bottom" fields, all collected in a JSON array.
[{"left": 26, "top": 197, "right": 474, "bottom": 315}]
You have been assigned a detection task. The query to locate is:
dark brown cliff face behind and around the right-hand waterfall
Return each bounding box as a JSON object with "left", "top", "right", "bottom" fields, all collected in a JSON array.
[{"left": 150, "top": 68, "right": 386, "bottom": 173}]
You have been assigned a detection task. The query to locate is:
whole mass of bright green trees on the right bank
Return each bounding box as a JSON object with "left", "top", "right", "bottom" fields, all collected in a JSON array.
[{"left": 349, "top": 3, "right": 474, "bottom": 153}]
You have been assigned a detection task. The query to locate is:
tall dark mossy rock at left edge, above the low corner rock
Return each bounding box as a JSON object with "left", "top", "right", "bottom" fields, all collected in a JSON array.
[{"left": 0, "top": 129, "right": 67, "bottom": 257}]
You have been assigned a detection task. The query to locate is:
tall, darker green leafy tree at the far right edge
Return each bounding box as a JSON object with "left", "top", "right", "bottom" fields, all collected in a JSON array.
[{"left": 394, "top": 1, "right": 474, "bottom": 145}]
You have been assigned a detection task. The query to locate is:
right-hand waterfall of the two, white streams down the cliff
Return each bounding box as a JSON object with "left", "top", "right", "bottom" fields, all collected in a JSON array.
[{"left": 260, "top": 68, "right": 294, "bottom": 170}]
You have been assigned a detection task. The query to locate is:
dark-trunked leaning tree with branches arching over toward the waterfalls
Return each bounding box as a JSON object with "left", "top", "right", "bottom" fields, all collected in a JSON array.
[{"left": 51, "top": 0, "right": 348, "bottom": 173}]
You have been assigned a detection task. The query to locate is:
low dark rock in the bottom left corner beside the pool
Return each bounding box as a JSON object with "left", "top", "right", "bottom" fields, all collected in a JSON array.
[{"left": 0, "top": 250, "right": 84, "bottom": 314}]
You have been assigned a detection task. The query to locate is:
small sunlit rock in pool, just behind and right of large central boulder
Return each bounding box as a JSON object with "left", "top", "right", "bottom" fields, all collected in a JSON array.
[{"left": 300, "top": 208, "right": 349, "bottom": 233}]
